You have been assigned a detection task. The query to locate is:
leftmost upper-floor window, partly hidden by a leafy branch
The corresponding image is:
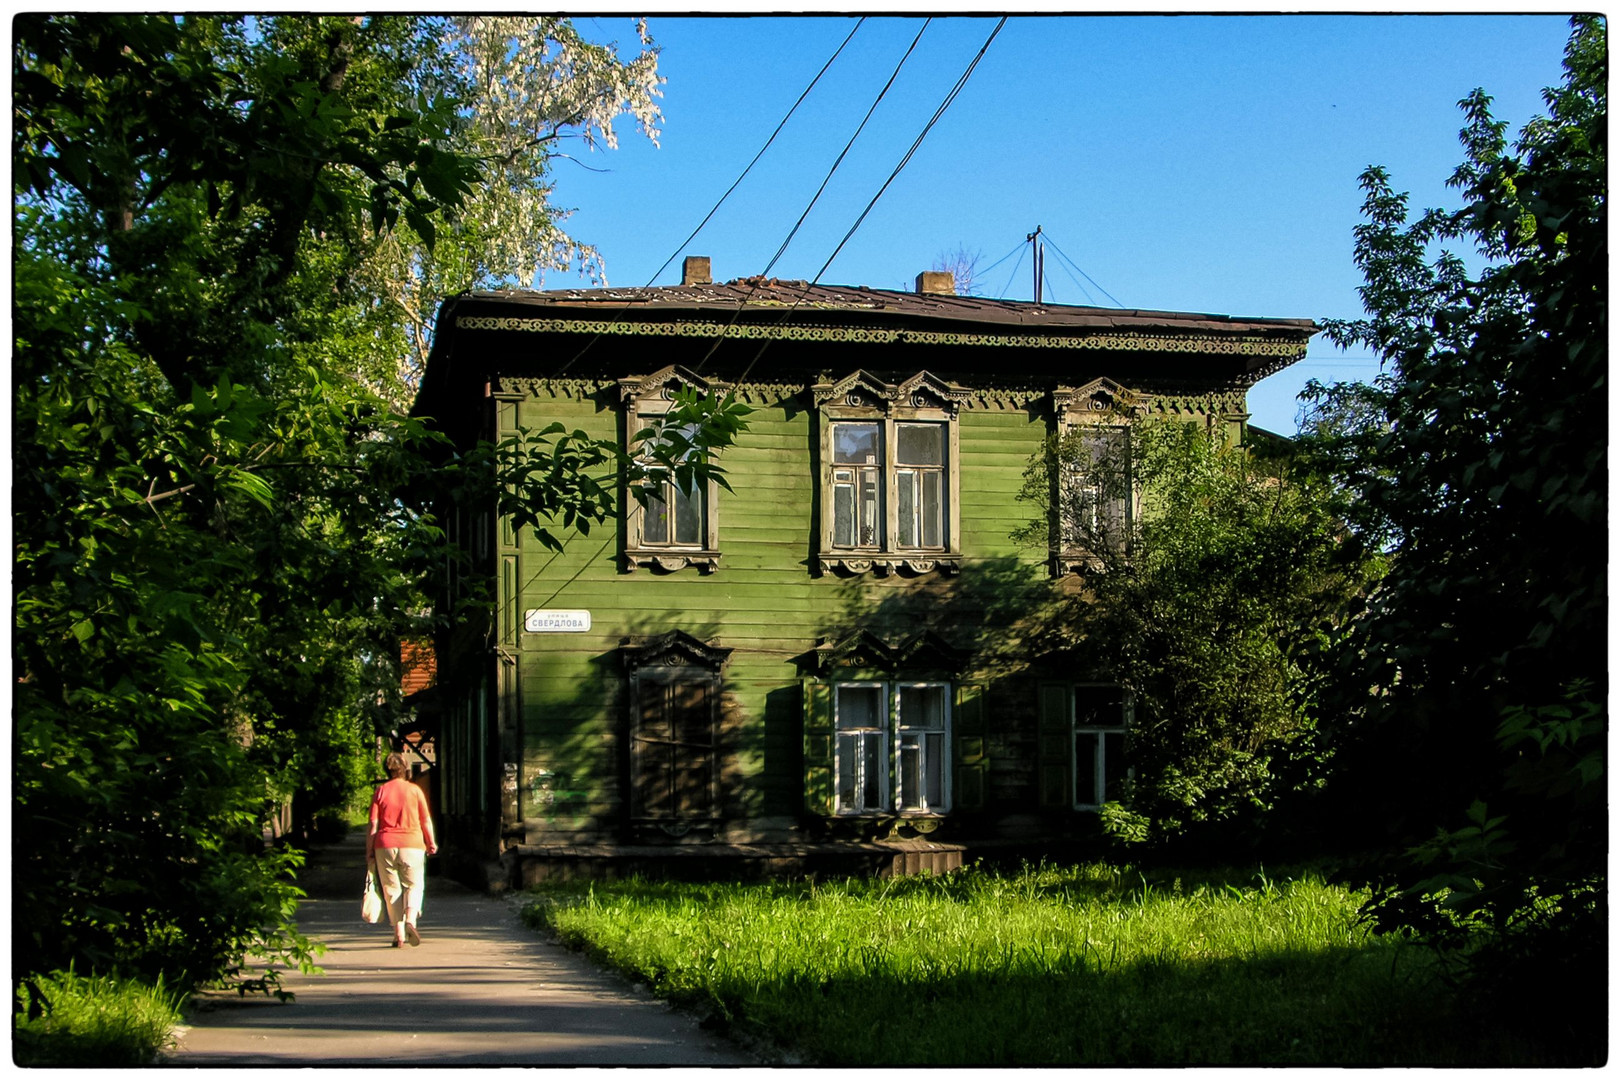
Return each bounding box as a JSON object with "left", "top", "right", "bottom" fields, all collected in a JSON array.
[{"left": 619, "top": 366, "right": 719, "bottom": 573}]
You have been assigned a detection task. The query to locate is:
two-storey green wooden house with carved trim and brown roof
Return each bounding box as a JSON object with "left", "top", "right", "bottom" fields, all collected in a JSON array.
[{"left": 416, "top": 259, "right": 1315, "bottom": 886}]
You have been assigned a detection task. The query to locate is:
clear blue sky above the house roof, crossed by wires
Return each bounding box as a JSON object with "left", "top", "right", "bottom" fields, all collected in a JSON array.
[{"left": 544, "top": 15, "right": 1568, "bottom": 432}]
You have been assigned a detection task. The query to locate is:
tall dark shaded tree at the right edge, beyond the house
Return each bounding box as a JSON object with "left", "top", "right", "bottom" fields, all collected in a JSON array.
[{"left": 1314, "top": 18, "right": 1607, "bottom": 1055}]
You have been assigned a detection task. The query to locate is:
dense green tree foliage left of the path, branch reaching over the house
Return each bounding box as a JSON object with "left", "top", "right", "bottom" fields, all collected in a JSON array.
[{"left": 13, "top": 15, "right": 745, "bottom": 988}]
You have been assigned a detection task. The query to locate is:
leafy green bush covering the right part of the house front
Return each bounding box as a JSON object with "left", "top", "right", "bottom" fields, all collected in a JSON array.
[{"left": 1022, "top": 419, "right": 1377, "bottom": 844}]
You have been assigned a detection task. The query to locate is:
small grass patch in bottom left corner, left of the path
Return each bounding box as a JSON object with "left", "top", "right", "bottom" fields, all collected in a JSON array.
[{"left": 11, "top": 972, "right": 181, "bottom": 1065}]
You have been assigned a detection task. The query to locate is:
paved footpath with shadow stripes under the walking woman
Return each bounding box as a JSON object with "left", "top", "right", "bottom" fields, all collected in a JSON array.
[{"left": 167, "top": 836, "right": 757, "bottom": 1065}]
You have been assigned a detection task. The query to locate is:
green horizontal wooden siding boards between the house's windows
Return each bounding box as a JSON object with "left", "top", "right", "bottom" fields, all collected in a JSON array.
[{"left": 498, "top": 383, "right": 1146, "bottom": 844}]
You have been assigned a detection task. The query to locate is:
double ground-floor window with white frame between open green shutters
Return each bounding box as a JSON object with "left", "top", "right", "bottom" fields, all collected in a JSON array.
[{"left": 833, "top": 682, "right": 951, "bottom": 814}]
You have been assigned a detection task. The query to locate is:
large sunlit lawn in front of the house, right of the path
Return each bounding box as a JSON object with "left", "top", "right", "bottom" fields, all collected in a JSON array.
[{"left": 525, "top": 865, "right": 1524, "bottom": 1065}]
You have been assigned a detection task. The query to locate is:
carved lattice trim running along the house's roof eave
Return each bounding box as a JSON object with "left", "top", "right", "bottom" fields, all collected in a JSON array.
[{"left": 455, "top": 316, "right": 1306, "bottom": 366}]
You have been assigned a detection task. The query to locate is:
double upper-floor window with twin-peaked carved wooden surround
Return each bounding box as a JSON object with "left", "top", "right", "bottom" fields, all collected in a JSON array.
[{"left": 815, "top": 371, "right": 961, "bottom": 573}]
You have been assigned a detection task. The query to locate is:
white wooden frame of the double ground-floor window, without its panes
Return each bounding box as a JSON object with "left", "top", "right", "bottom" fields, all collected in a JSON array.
[{"left": 833, "top": 680, "right": 954, "bottom": 818}]
